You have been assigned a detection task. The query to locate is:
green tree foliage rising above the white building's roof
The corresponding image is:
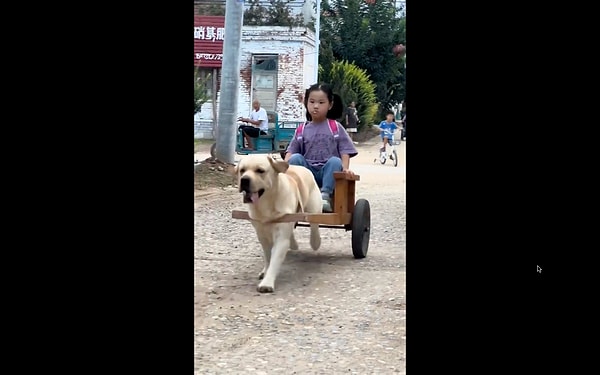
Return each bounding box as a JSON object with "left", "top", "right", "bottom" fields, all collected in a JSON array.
[{"left": 244, "top": 0, "right": 306, "bottom": 27}]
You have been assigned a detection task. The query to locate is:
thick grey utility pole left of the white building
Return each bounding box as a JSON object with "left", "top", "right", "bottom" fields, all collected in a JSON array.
[{"left": 216, "top": 0, "right": 244, "bottom": 164}]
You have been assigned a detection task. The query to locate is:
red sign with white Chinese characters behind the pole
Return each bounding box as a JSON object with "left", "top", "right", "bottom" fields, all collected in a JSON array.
[{"left": 194, "top": 16, "right": 225, "bottom": 68}]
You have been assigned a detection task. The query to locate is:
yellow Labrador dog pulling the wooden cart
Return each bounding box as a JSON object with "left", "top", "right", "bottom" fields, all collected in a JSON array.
[{"left": 236, "top": 155, "right": 323, "bottom": 293}]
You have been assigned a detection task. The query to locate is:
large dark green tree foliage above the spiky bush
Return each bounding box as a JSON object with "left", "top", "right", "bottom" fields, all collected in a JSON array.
[{"left": 319, "top": 0, "right": 406, "bottom": 115}]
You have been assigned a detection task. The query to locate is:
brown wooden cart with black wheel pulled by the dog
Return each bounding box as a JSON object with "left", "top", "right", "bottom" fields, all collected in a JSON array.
[{"left": 231, "top": 172, "right": 371, "bottom": 259}]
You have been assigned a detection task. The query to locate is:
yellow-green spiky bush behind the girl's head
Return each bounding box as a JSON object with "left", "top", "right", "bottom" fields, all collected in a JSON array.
[{"left": 319, "top": 61, "right": 378, "bottom": 132}]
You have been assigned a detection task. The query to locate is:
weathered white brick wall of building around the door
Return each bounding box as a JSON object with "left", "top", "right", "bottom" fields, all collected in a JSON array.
[{"left": 194, "top": 26, "right": 315, "bottom": 138}]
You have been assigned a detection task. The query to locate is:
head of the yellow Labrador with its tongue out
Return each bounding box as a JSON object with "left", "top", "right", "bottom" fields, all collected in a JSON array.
[{"left": 235, "top": 155, "right": 289, "bottom": 204}]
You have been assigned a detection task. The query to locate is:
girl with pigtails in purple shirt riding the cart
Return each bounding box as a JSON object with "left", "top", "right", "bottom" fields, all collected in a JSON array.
[{"left": 285, "top": 84, "right": 358, "bottom": 212}]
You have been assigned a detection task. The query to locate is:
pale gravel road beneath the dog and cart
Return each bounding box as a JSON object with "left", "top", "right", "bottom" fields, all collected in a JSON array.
[{"left": 194, "top": 139, "right": 406, "bottom": 374}]
